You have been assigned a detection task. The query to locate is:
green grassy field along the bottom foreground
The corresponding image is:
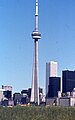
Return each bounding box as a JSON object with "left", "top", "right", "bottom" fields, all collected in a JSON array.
[{"left": 0, "top": 107, "right": 75, "bottom": 120}]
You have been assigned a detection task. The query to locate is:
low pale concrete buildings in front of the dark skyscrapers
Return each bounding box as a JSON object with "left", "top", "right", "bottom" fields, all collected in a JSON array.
[{"left": 46, "top": 89, "right": 75, "bottom": 106}]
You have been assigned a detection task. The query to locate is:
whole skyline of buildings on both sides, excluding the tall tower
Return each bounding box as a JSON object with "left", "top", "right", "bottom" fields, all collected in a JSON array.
[{"left": 0, "top": 61, "right": 75, "bottom": 106}]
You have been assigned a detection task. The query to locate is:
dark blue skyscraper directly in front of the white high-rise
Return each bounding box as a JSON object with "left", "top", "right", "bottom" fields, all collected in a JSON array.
[{"left": 48, "top": 77, "right": 61, "bottom": 98}]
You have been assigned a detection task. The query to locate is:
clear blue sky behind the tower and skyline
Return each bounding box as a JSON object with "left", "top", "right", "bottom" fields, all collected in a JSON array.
[{"left": 0, "top": 0, "right": 75, "bottom": 92}]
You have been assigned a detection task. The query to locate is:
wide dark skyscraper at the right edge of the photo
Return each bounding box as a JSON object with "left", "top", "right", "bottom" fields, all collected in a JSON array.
[{"left": 62, "top": 70, "right": 75, "bottom": 93}]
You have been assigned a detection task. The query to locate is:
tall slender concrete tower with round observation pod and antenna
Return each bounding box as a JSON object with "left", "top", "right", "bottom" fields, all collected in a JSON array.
[{"left": 31, "top": 0, "right": 41, "bottom": 105}]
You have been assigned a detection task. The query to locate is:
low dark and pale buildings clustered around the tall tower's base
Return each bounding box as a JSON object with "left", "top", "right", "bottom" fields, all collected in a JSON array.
[{"left": 0, "top": 85, "right": 45, "bottom": 106}]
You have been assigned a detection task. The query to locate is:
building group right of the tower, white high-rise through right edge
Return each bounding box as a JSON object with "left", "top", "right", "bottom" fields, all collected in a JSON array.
[{"left": 46, "top": 61, "right": 75, "bottom": 106}]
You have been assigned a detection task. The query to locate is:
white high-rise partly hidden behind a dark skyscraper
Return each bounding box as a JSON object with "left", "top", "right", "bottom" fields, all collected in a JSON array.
[{"left": 46, "top": 61, "right": 57, "bottom": 96}]
